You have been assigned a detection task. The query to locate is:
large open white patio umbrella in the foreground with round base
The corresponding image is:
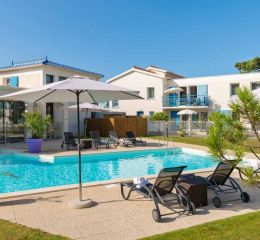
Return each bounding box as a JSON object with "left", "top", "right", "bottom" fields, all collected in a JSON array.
[{"left": 0, "top": 76, "right": 142, "bottom": 208}]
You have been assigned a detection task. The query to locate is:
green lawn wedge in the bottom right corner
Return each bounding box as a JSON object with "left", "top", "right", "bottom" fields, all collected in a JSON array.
[{"left": 143, "top": 212, "right": 260, "bottom": 240}]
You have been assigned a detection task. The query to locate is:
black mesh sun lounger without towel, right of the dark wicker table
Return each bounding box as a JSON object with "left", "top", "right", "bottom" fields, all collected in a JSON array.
[{"left": 206, "top": 162, "right": 250, "bottom": 208}]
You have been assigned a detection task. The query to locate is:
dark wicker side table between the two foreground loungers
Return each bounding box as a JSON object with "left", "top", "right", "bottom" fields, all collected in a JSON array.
[{"left": 178, "top": 174, "right": 208, "bottom": 208}]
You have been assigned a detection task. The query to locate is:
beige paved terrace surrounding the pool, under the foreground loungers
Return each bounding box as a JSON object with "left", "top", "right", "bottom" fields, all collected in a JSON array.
[{"left": 0, "top": 141, "right": 260, "bottom": 240}]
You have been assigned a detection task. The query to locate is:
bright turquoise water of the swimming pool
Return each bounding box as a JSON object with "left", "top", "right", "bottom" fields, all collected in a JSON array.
[{"left": 0, "top": 149, "right": 216, "bottom": 193}]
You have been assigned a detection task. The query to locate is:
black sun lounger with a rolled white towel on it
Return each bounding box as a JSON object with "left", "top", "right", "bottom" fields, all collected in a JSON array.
[{"left": 120, "top": 166, "right": 196, "bottom": 222}]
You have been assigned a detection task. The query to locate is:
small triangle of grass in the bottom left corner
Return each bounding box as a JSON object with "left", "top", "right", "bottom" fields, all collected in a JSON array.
[{"left": 0, "top": 220, "right": 69, "bottom": 240}]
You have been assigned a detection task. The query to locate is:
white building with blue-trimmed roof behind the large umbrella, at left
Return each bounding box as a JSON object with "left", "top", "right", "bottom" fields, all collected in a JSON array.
[{"left": 0, "top": 58, "right": 103, "bottom": 140}]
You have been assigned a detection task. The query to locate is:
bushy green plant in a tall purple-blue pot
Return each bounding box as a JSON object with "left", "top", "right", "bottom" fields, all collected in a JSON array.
[{"left": 23, "top": 111, "right": 52, "bottom": 153}]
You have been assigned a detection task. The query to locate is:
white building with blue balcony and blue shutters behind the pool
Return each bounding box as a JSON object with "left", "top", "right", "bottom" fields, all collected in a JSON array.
[{"left": 105, "top": 66, "right": 260, "bottom": 121}]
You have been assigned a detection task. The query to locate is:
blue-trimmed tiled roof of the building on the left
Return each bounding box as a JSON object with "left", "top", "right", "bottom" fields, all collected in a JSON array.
[{"left": 0, "top": 58, "right": 104, "bottom": 77}]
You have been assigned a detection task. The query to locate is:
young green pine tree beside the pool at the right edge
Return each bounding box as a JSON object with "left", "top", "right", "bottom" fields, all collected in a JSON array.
[{"left": 207, "top": 88, "right": 260, "bottom": 185}]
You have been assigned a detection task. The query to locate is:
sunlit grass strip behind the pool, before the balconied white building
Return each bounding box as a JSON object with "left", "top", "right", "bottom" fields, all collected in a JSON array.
[{"left": 149, "top": 136, "right": 260, "bottom": 153}]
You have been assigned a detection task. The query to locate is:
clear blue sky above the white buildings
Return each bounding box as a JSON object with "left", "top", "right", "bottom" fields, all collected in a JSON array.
[{"left": 0, "top": 0, "right": 260, "bottom": 79}]
